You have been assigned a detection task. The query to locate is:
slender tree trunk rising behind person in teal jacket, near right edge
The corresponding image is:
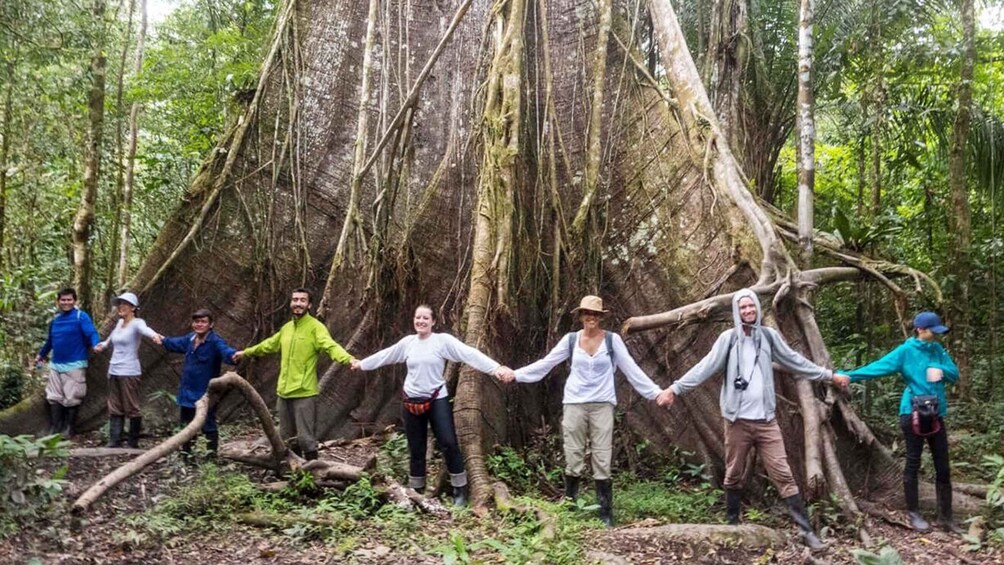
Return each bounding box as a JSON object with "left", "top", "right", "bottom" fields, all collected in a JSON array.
[{"left": 948, "top": 0, "right": 976, "bottom": 398}]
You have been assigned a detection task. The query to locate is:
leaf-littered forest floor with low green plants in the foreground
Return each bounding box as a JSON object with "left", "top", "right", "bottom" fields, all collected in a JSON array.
[{"left": 0, "top": 429, "right": 1004, "bottom": 565}]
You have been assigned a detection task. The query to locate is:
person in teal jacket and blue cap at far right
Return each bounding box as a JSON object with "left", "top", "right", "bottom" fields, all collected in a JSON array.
[{"left": 840, "top": 312, "right": 961, "bottom": 533}]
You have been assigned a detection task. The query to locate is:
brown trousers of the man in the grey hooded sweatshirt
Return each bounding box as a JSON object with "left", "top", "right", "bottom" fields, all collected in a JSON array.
[{"left": 725, "top": 419, "right": 798, "bottom": 499}]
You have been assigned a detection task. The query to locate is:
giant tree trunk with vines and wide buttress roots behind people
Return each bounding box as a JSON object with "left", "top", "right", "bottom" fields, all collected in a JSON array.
[{"left": 0, "top": 0, "right": 971, "bottom": 513}]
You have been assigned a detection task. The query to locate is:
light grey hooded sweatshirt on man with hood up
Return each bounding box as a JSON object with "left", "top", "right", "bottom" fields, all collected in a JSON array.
[{"left": 670, "top": 288, "right": 833, "bottom": 421}]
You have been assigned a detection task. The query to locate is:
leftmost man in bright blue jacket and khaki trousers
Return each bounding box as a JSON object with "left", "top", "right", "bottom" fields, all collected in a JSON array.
[{"left": 35, "top": 287, "right": 100, "bottom": 438}]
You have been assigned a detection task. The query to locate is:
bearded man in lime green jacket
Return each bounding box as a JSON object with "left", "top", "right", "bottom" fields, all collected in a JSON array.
[{"left": 234, "top": 288, "right": 355, "bottom": 461}]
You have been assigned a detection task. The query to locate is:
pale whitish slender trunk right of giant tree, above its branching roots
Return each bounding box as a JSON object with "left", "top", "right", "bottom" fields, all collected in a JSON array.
[{"left": 797, "top": 0, "right": 815, "bottom": 269}]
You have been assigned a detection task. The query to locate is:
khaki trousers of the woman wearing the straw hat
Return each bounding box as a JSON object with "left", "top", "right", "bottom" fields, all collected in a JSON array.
[{"left": 561, "top": 402, "right": 613, "bottom": 481}]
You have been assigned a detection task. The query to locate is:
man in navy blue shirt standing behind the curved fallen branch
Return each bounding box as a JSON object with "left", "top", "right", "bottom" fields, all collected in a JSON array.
[{"left": 161, "top": 309, "right": 236, "bottom": 458}]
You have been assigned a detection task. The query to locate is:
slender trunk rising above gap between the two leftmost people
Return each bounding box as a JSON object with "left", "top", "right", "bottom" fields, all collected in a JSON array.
[{"left": 72, "top": 0, "right": 105, "bottom": 310}]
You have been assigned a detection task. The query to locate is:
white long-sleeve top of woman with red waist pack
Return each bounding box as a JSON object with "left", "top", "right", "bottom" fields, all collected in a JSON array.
[{"left": 359, "top": 333, "right": 500, "bottom": 398}]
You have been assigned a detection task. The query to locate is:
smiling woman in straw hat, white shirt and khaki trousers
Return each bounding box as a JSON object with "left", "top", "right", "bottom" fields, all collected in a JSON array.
[{"left": 508, "top": 296, "right": 663, "bottom": 527}]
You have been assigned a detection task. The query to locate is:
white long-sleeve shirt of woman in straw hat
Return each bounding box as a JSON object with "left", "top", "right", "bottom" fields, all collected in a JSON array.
[{"left": 516, "top": 330, "right": 663, "bottom": 405}]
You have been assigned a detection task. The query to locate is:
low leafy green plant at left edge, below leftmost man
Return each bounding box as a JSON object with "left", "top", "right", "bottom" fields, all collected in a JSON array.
[{"left": 0, "top": 435, "right": 69, "bottom": 538}]
